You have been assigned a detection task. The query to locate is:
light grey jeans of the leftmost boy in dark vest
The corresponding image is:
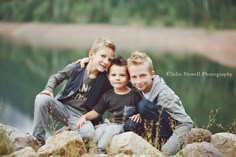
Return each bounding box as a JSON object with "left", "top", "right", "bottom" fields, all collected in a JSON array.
[{"left": 33, "top": 94, "right": 95, "bottom": 141}]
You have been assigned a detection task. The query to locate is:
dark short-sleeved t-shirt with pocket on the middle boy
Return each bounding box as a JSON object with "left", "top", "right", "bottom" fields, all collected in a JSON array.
[{"left": 93, "top": 89, "right": 141, "bottom": 123}]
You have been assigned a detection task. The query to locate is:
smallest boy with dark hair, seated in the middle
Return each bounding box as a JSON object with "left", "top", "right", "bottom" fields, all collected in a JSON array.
[{"left": 77, "top": 56, "right": 142, "bottom": 152}]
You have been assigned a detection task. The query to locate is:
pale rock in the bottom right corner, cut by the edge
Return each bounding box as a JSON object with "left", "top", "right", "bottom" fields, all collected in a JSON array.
[{"left": 211, "top": 133, "right": 236, "bottom": 157}]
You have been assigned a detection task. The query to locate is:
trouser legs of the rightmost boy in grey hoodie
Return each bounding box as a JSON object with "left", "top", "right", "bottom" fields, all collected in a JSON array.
[{"left": 138, "top": 99, "right": 193, "bottom": 155}]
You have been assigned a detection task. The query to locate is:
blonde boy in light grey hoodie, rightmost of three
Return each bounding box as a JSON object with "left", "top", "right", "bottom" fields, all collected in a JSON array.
[{"left": 128, "top": 51, "right": 193, "bottom": 155}]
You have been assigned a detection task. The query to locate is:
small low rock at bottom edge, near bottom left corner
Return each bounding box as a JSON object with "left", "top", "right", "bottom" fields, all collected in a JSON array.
[{"left": 8, "top": 147, "right": 37, "bottom": 157}]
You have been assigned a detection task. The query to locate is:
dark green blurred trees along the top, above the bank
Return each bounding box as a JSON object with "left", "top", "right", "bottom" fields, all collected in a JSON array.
[{"left": 0, "top": 0, "right": 236, "bottom": 28}]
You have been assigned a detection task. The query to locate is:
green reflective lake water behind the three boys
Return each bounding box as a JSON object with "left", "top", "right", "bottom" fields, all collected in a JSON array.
[{"left": 0, "top": 40, "right": 236, "bottom": 132}]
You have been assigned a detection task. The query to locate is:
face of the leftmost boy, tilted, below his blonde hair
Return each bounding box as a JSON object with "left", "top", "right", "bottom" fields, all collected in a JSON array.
[{"left": 89, "top": 48, "right": 115, "bottom": 72}]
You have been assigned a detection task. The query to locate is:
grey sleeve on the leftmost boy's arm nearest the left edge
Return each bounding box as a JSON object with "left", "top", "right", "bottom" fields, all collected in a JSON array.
[{"left": 45, "top": 63, "right": 76, "bottom": 92}]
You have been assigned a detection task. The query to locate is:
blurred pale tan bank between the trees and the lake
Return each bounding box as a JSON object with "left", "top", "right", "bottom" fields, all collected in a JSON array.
[{"left": 0, "top": 22, "right": 236, "bottom": 67}]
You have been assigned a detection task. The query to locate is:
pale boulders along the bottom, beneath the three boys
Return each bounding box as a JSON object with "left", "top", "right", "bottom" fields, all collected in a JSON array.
[{"left": 0, "top": 123, "right": 236, "bottom": 157}]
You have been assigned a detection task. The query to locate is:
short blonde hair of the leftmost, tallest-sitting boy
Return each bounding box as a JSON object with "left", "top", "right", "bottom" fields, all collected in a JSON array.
[{"left": 91, "top": 37, "right": 116, "bottom": 52}]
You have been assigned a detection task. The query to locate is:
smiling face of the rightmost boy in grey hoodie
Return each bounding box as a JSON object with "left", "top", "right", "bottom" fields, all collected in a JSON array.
[{"left": 129, "top": 64, "right": 155, "bottom": 93}]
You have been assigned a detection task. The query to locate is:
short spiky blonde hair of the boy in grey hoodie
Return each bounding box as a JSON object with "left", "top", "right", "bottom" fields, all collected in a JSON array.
[{"left": 127, "top": 51, "right": 153, "bottom": 71}]
